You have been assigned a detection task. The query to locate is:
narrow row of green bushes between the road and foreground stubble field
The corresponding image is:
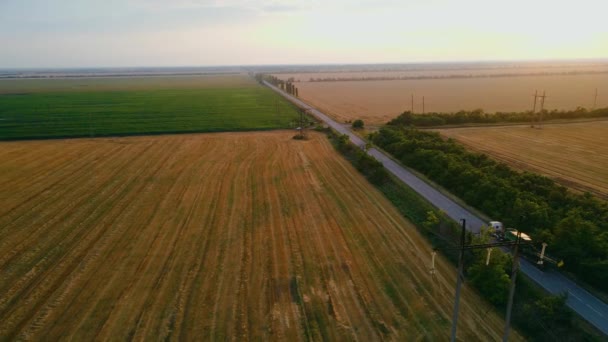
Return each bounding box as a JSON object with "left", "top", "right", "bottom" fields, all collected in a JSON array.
[{"left": 325, "top": 130, "right": 594, "bottom": 341}]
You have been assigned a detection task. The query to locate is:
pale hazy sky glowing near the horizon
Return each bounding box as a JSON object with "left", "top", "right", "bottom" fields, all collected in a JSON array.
[{"left": 0, "top": 0, "right": 608, "bottom": 68}]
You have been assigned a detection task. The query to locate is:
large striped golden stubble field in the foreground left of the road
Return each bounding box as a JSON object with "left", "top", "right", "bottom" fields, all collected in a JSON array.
[{"left": 0, "top": 132, "right": 520, "bottom": 341}]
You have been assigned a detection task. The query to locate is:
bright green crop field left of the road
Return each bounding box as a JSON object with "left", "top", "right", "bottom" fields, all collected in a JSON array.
[{"left": 0, "top": 75, "right": 297, "bottom": 140}]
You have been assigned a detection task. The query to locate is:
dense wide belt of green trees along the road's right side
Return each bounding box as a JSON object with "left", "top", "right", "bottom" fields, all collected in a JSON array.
[{"left": 371, "top": 122, "right": 608, "bottom": 291}]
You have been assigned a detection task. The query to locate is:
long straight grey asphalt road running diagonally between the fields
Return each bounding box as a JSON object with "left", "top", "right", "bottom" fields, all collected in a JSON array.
[{"left": 264, "top": 82, "right": 608, "bottom": 335}]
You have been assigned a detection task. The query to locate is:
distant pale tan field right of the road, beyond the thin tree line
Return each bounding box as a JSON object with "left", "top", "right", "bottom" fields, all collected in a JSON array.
[{"left": 284, "top": 73, "right": 608, "bottom": 125}]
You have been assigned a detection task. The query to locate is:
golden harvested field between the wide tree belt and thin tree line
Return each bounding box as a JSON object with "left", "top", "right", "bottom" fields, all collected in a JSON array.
[{"left": 440, "top": 121, "right": 608, "bottom": 197}]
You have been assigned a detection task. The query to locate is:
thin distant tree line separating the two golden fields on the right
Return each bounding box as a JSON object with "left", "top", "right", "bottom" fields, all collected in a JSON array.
[{"left": 389, "top": 107, "right": 608, "bottom": 127}]
